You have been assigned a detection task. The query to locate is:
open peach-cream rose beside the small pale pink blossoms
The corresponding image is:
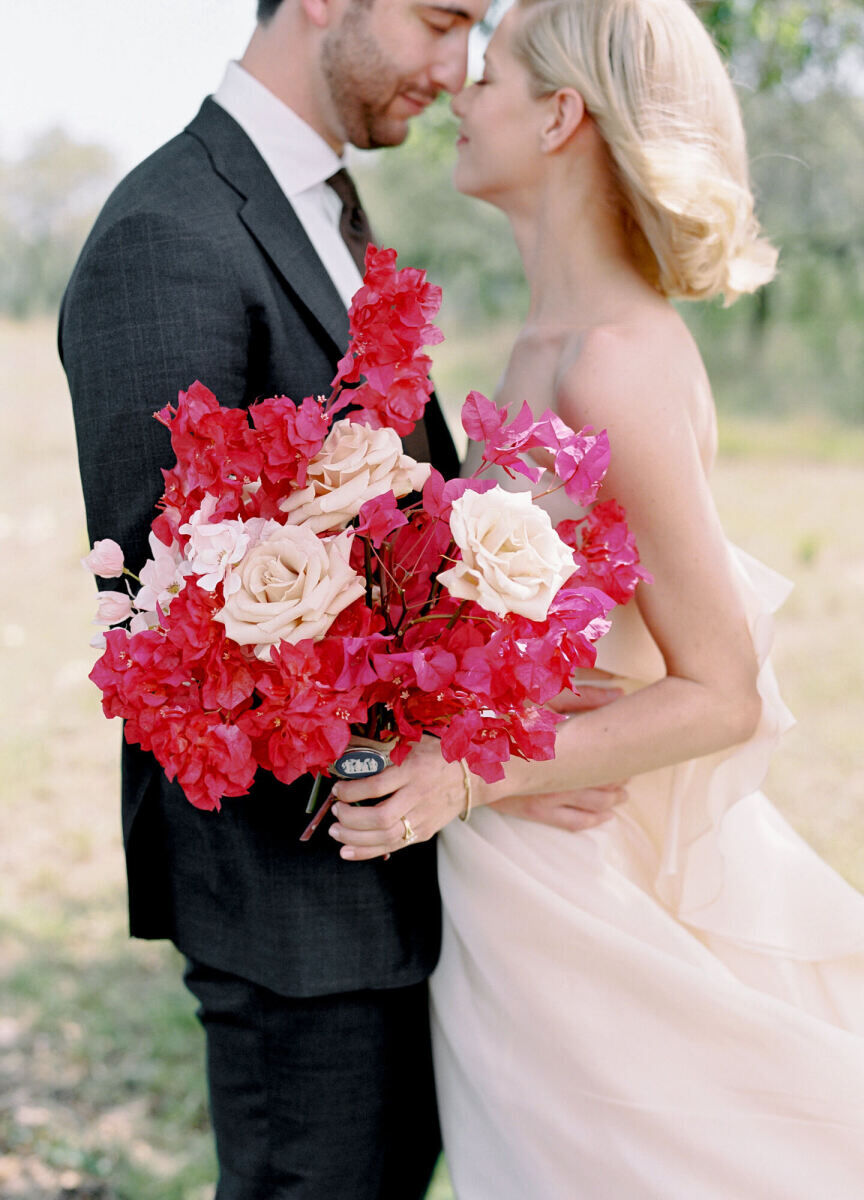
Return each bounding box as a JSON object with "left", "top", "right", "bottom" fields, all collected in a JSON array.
[{"left": 215, "top": 526, "right": 365, "bottom": 659}]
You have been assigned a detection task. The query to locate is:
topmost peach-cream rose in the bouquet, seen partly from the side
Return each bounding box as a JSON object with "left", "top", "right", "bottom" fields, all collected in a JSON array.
[{"left": 280, "top": 421, "right": 432, "bottom": 533}]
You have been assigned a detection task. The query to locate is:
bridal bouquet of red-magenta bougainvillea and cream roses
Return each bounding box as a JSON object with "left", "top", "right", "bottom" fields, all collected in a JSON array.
[{"left": 84, "top": 247, "right": 644, "bottom": 825}]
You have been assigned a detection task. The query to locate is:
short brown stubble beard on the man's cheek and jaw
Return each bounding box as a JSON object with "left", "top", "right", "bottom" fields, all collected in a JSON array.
[{"left": 320, "top": 5, "right": 408, "bottom": 150}]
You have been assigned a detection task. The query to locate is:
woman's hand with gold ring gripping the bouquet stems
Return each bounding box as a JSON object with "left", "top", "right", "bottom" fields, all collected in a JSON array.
[{"left": 329, "top": 736, "right": 472, "bottom": 862}]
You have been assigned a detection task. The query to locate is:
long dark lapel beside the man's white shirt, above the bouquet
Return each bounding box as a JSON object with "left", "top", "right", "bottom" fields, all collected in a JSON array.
[{"left": 186, "top": 97, "right": 348, "bottom": 355}]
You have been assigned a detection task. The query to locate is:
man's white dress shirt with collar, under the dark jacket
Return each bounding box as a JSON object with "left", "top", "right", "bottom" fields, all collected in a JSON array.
[{"left": 214, "top": 62, "right": 361, "bottom": 307}]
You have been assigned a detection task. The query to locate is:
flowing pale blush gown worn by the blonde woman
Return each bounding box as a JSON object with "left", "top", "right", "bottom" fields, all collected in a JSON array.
[{"left": 432, "top": 548, "right": 864, "bottom": 1200}]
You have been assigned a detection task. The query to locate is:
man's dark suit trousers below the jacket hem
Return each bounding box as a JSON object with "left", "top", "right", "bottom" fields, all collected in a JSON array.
[{"left": 186, "top": 962, "right": 440, "bottom": 1200}]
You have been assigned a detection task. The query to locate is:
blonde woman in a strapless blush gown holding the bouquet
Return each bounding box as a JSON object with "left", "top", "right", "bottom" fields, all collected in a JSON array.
[{"left": 331, "top": 0, "right": 864, "bottom": 1200}]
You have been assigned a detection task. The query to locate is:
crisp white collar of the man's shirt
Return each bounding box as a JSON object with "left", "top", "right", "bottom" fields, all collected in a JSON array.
[{"left": 212, "top": 62, "right": 346, "bottom": 198}]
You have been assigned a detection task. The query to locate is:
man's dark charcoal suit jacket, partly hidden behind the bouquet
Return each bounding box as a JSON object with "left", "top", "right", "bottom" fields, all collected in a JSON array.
[{"left": 60, "top": 100, "right": 457, "bottom": 996}]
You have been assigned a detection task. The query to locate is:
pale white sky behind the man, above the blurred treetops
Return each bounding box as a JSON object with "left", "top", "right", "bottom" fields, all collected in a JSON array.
[{"left": 0, "top": 0, "right": 256, "bottom": 167}]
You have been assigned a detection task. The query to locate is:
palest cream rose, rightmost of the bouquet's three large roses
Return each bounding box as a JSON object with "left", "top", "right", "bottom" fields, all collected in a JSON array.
[{"left": 438, "top": 485, "right": 574, "bottom": 620}]
